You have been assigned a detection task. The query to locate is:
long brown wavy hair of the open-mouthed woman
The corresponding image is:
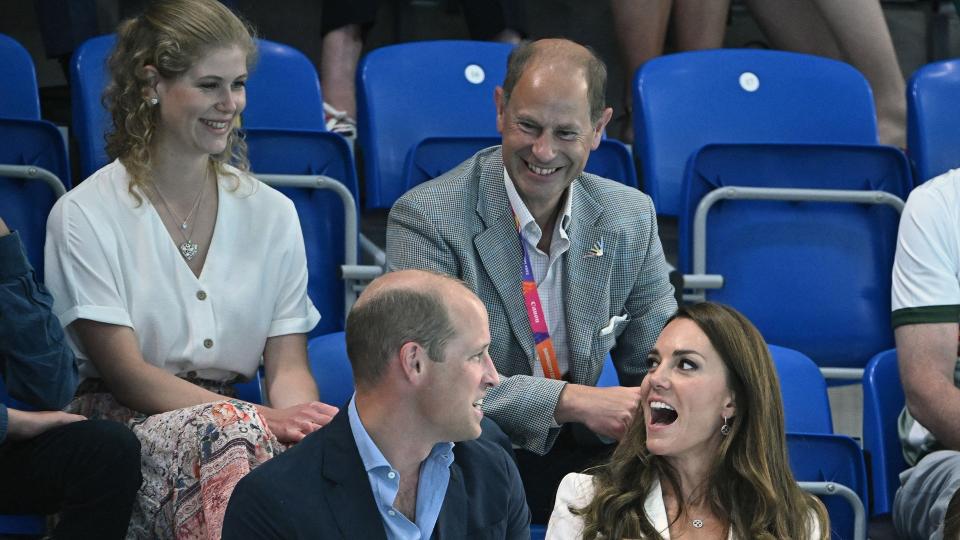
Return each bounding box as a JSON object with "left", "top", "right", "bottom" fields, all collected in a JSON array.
[{"left": 570, "top": 302, "right": 829, "bottom": 540}]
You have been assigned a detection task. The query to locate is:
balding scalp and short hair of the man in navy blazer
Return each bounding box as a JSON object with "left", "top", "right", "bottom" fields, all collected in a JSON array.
[{"left": 346, "top": 270, "right": 480, "bottom": 387}]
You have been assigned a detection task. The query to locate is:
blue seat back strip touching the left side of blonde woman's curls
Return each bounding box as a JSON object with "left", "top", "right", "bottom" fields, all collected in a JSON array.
[{"left": 70, "top": 34, "right": 116, "bottom": 178}]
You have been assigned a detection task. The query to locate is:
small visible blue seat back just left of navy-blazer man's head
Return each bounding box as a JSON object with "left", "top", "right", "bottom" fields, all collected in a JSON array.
[{"left": 307, "top": 332, "right": 353, "bottom": 410}]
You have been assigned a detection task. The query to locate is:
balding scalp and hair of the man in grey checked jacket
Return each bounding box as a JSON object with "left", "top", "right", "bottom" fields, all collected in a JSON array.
[{"left": 503, "top": 39, "right": 607, "bottom": 123}]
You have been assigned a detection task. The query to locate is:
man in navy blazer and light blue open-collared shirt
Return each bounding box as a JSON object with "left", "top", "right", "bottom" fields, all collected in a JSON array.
[{"left": 223, "top": 270, "right": 530, "bottom": 540}]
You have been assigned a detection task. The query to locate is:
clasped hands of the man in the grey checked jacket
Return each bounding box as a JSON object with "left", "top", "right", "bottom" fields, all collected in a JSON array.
[{"left": 554, "top": 384, "right": 640, "bottom": 440}]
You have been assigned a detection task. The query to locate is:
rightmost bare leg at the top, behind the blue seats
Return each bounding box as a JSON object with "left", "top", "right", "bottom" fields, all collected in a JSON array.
[{"left": 816, "top": 0, "right": 907, "bottom": 148}]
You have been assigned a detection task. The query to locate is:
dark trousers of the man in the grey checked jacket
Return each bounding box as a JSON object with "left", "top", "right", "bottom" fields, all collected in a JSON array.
[{"left": 514, "top": 424, "right": 616, "bottom": 524}]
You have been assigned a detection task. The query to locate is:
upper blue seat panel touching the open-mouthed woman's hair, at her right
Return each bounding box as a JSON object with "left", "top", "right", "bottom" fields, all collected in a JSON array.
[{"left": 767, "top": 345, "right": 833, "bottom": 434}]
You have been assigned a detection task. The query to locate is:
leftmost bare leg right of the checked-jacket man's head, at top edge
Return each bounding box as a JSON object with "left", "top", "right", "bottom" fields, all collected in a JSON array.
[{"left": 610, "top": 0, "right": 673, "bottom": 144}]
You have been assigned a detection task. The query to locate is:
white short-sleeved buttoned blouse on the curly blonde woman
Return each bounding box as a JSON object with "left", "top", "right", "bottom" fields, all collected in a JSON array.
[{"left": 44, "top": 161, "right": 320, "bottom": 380}]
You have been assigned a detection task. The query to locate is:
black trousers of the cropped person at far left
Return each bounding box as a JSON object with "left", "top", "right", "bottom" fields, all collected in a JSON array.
[{"left": 0, "top": 420, "right": 141, "bottom": 539}]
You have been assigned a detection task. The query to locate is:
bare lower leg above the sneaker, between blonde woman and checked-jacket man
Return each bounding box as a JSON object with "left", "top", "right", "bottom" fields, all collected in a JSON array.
[{"left": 320, "top": 24, "right": 363, "bottom": 118}]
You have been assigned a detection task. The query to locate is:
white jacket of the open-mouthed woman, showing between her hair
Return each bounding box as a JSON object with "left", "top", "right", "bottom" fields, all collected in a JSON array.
[{"left": 546, "top": 473, "right": 820, "bottom": 540}]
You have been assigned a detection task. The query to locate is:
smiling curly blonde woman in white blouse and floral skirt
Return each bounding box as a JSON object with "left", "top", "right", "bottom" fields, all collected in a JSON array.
[{"left": 46, "top": 0, "right": 337, "bottom": 538}]
